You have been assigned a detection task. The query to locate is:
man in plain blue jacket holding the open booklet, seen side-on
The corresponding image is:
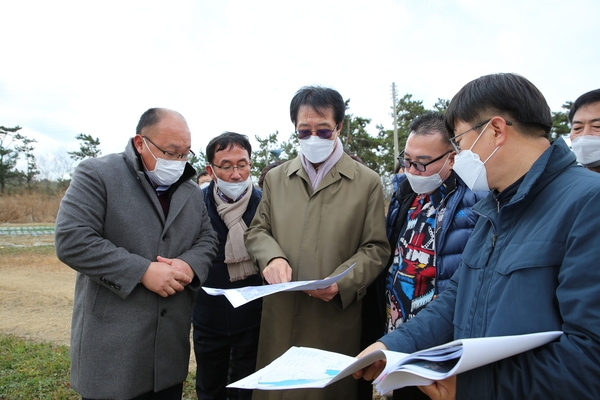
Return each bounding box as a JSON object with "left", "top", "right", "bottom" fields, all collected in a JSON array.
[{"left": 355, "top": 74, "right": 600, "bottom": 399}]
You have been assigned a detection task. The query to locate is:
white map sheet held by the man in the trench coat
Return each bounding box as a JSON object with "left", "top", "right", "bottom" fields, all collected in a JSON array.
[{"left": 202, "top": 264, "right": 355, "bottom": 308}]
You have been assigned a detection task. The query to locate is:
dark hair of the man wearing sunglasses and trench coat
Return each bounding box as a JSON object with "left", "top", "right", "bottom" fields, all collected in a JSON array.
[{"left": 290, "top": 86, "right": 346, "bottom": 126}]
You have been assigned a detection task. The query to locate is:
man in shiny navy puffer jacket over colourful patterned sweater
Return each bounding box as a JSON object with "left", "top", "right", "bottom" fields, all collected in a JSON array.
[{"left": 385, "top": 112, "right": 488, "bottom": 399}]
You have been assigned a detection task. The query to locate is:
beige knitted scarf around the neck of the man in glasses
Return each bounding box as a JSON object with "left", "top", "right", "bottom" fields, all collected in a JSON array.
[{"left": 213, "top": 181, "right": 257, "bottom": 282}]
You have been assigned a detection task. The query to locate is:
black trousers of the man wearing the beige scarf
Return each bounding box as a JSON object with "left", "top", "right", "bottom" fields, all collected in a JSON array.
[{"left": 194, "top": 326, "right": 259, "bottom": 400}]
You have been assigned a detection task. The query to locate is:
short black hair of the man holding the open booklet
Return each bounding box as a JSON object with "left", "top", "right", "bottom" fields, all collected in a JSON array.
[{"left": 445, "top": 73, "right": 552, "bottom": 138}]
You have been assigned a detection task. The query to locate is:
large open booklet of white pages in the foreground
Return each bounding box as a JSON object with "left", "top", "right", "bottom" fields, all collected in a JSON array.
[{"left": 228, "top": 331, "right": 562, "bottom": 394}]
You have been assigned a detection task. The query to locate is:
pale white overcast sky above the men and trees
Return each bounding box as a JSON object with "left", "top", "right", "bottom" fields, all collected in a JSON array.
[{"left": 0, "top": 0, "right": 600, "bottom": 177}]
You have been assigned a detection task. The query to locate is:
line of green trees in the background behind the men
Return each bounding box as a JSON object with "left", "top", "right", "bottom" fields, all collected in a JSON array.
[{"left": 0, "top": 94, "right": 573, "bottom": 195}]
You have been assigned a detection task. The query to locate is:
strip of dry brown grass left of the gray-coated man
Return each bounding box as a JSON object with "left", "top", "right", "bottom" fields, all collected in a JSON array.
[{"left": 0, "top": 192, "right": 63, "bottom": 224}]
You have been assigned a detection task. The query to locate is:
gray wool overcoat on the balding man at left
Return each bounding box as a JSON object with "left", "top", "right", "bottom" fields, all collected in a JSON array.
[{"left": 55, "top": 140, "right": 217, "bottom": 399}]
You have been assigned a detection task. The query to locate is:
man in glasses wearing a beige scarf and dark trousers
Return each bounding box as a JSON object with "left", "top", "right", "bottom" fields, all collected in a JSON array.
[{"left": 193, "top": 132, "right": 262, "bottom": 400}]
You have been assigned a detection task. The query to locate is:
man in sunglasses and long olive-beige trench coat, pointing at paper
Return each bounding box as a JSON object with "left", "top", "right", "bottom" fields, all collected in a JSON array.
[{"left": 245, "top": 87, "right": 390, "bottom": 400}]
